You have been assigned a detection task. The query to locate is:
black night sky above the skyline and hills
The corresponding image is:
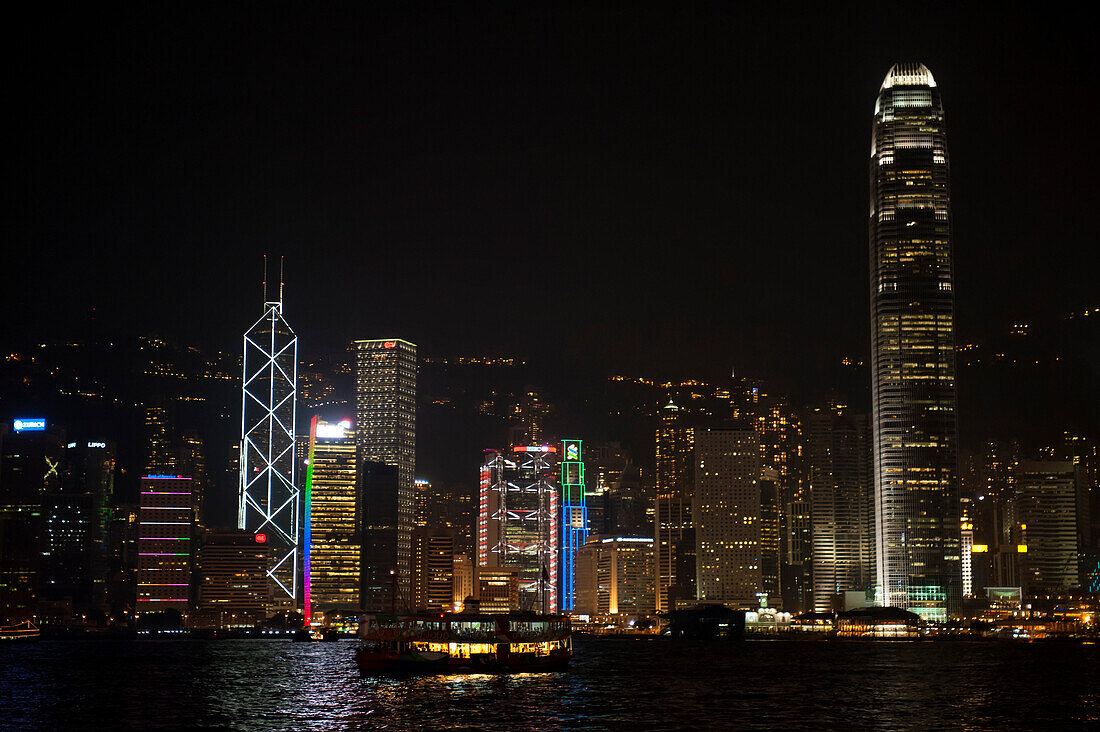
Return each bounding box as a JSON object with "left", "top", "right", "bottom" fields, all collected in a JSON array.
[{"left": 10, "top": 3, "right": 1100, "bottom": 381}]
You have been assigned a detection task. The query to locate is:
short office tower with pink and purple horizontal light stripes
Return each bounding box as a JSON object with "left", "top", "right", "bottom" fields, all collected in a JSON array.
[{"left": 136, "top": 476, "right": 195, "bottom": 618}]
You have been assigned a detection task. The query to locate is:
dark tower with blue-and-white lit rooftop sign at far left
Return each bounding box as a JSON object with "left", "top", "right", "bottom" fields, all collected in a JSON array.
[{"left": 0, "top": 417, "right": 65, "bottom": 623}]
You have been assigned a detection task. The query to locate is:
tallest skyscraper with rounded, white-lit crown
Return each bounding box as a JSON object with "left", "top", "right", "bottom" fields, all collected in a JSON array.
[{"left": 869, "top": 63, "right": 961, "bottom": 620}]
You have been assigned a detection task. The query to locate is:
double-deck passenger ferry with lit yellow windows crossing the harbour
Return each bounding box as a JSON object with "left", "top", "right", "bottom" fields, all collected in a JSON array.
[{"left": 355, "top": 613, "right": 573, "bottom": 673}]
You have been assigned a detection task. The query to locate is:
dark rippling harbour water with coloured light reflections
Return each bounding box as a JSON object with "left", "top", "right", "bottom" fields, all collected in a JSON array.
[{"left": 0, "top": 638, "right": 1100, "bottom": 731}]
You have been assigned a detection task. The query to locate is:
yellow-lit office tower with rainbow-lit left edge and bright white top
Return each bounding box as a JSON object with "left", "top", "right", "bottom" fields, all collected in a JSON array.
[{"left": 303, "top": 417, "right": 362, "bottom": 614}]
